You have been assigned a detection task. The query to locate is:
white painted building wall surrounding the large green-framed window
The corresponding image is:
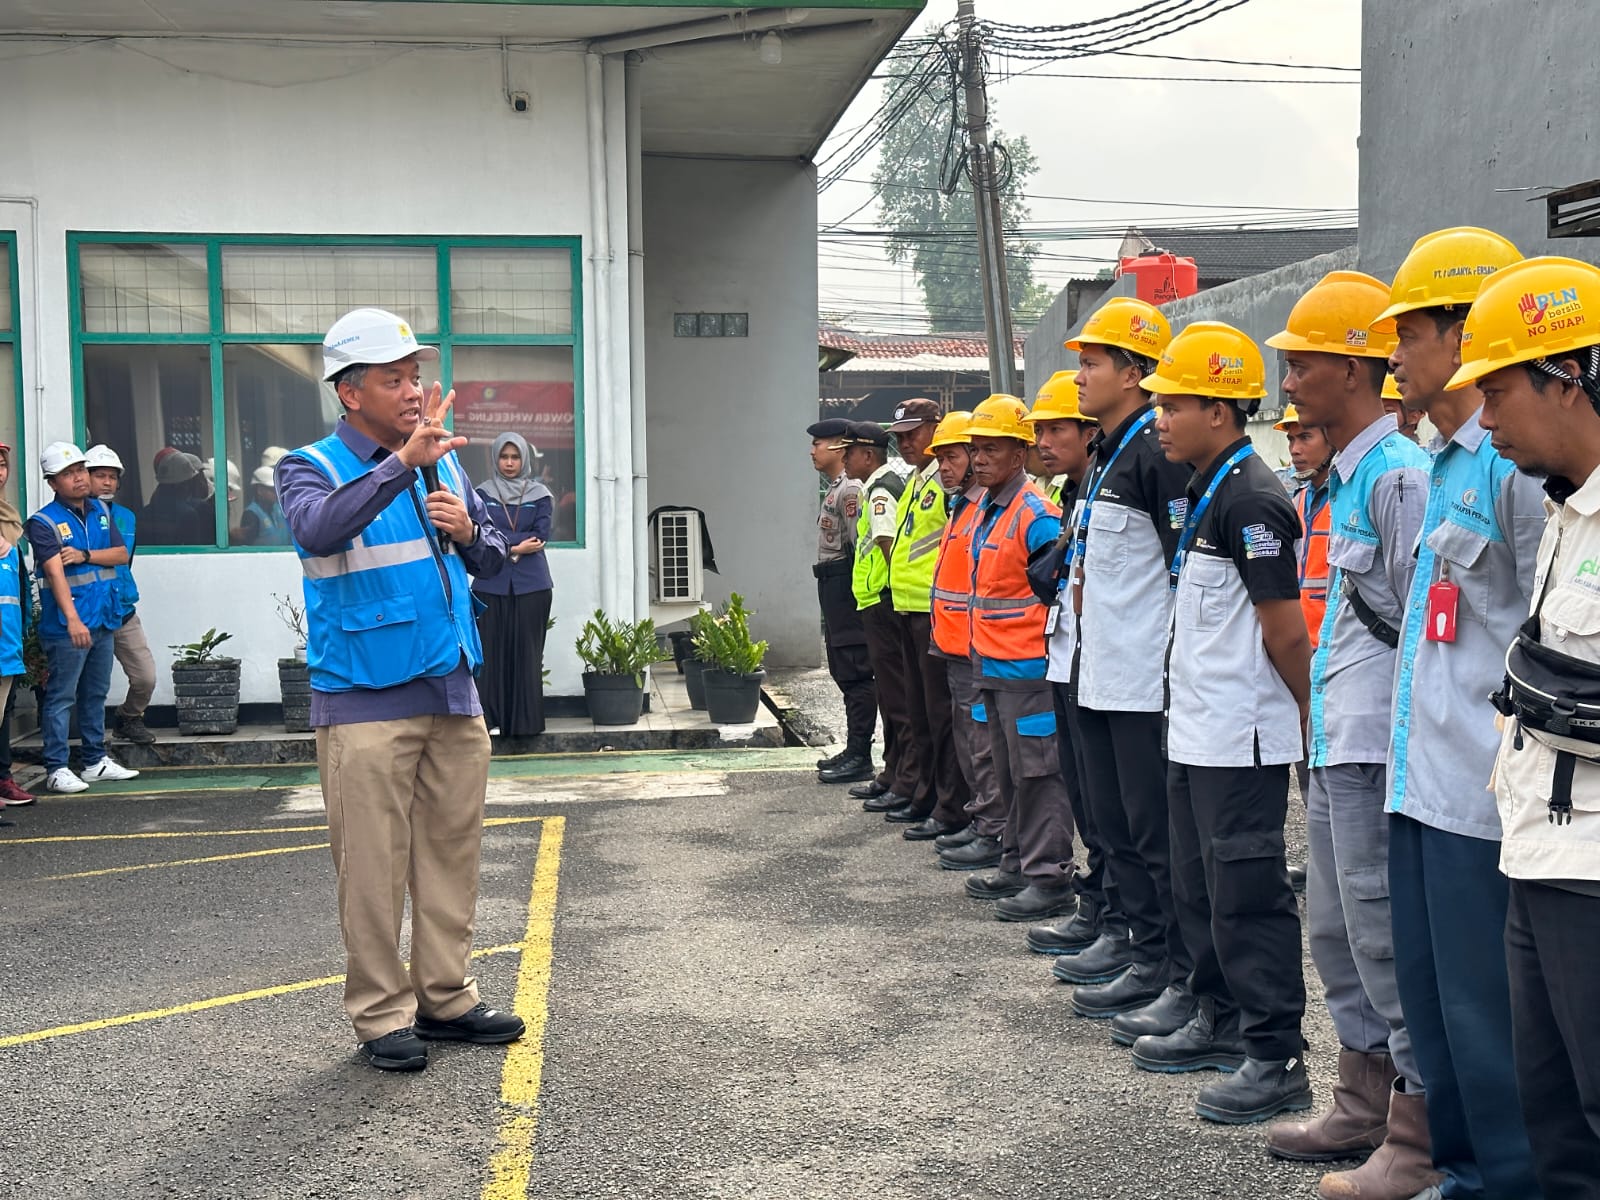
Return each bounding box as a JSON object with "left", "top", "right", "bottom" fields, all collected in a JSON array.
[{"left": 0, "top": 40, "right": 627, "bottom": 704}]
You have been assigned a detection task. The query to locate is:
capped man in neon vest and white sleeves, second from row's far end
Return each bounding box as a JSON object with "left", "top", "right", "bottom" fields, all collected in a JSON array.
[{"left": 845, "top": 421, "right": 917, "bottom": 813}]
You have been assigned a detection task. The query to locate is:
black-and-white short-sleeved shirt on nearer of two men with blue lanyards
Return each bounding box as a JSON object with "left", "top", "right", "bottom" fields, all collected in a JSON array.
[{"left": 1166, "top": 438, "right": 1304, "bottom": 766}]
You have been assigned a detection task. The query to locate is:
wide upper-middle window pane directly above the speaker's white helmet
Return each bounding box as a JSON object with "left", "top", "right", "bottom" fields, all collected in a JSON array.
[{"left": 222, "top": 246, "right": 438, "bottom": 336}]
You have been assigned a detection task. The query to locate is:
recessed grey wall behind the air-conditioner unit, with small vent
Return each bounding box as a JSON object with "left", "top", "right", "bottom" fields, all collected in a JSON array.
[{"left": 643, "top": 158, "right": 821, "bottom": 666}]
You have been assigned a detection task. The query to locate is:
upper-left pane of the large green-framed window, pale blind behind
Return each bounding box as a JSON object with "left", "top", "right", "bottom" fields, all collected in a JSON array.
[{"left": 78, "top": 243, "right": 211, "bottom": 333}]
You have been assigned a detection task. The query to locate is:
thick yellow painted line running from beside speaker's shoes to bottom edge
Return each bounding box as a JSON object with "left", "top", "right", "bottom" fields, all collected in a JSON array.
[{"left": 482, "top": 816, "right": 566, "bottom": 1200}]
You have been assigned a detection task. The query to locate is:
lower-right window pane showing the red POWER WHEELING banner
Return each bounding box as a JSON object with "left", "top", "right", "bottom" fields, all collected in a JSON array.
[{"left": 451, "top": 346, "right": 578, "bottom": 541}]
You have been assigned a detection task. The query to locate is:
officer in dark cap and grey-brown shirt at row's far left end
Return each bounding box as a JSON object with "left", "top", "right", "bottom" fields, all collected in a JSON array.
[{"left": 806, "top": 418, "right": 878, "bottom": 784}]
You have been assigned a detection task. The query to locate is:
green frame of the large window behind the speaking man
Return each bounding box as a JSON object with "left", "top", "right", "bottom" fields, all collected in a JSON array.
[{"left": 70, "top": 230, "right": 587, "bottom": 555}]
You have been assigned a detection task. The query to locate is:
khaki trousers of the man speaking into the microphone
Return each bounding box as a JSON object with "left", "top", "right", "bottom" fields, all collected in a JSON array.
[{"left": 317, "top": 717, "right": 490, "bottom": 1042}]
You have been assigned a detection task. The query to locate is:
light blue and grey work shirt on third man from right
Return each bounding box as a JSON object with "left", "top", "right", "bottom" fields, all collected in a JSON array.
[{"left": 1310, "top": 413, "right": 1429, "bottom": 766}]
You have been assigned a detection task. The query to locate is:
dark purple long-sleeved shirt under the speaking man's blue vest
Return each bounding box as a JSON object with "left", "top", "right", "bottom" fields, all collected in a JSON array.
[{"left": 277, "top": 419, "right": 506, "bottom": 728}]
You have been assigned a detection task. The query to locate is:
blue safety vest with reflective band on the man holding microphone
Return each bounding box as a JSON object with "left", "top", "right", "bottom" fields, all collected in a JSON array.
[{"left": 293, "top": 434, "right": 483, "bottom": 691}]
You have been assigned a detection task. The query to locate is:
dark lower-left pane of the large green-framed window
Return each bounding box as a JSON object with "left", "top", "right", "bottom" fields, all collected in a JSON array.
[{"left": 83, "top": 346, "right": 216, "bottom": 546}]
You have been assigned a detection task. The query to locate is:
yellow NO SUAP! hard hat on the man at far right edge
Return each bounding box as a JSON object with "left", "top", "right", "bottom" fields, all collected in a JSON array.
[{"left": 1445, "top": 256, "right": 1600, "bottom": 392}]
